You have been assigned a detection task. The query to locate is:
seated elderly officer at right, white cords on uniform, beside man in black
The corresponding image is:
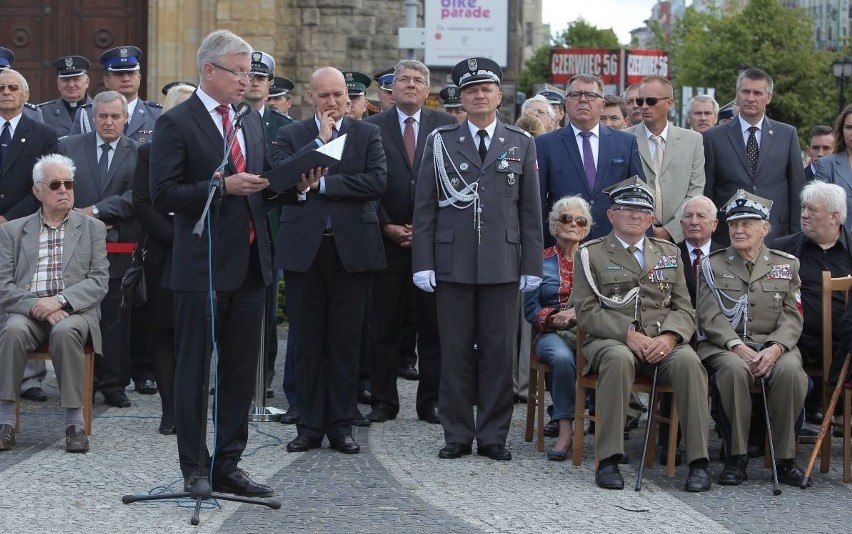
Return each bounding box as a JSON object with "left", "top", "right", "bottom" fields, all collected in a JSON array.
[{"left": 697, "top": 189, "right": 808, "bottom": 486}]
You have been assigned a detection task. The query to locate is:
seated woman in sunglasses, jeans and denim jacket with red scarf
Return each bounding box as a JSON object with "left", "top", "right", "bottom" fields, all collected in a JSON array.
[{"left": 524, "top": 196, "right": 592, "bottom": 462}]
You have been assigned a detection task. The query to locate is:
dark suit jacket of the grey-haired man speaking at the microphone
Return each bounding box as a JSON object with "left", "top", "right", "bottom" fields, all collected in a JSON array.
[{"left": 151, "top": 94, "right": 272, "bottom": 291}]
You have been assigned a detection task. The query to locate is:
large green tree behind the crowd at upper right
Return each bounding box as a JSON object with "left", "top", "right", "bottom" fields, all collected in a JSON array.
[{"left": 670, "top": 0, "right": 837, "bottom": 139}]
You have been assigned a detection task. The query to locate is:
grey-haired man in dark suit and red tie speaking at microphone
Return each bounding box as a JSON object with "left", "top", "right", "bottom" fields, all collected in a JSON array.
[{"left": 151, "top": 30, "right": 272, "bottom": 497}]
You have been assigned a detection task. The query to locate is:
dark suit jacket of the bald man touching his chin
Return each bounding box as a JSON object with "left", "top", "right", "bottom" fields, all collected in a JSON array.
[{"left": 272, "top": 117, "right": 387, "bottom": 273}]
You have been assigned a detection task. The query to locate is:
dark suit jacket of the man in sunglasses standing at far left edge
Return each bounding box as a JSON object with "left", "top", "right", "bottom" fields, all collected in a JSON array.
[{"left": 0, "top": 114, "right": 57, "bottom": 220}]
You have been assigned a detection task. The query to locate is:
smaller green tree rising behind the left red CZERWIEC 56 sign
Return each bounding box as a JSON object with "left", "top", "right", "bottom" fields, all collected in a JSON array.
[{"left": 518, "top": 18, "right": 620, "bottom": 95}]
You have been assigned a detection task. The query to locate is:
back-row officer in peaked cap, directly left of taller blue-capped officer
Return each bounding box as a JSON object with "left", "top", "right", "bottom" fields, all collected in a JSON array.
[{"left": 38, "top": 56, "right": 92, "bottom": 137}]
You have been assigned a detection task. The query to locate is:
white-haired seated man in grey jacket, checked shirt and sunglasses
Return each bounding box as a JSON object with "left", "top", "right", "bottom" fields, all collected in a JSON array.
[{"left": 0, "top": 154, "right": 109, "bottom": 452}]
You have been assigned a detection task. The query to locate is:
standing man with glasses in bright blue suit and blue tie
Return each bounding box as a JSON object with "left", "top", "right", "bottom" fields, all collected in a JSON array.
[{"left": 536, "top": 74, "right": 645, "bottom": 246}]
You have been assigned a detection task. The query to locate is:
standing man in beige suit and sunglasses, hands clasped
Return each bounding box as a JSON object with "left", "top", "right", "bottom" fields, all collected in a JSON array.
[{"left": 626, "top": 75, "right": 705, "bottom": 243}]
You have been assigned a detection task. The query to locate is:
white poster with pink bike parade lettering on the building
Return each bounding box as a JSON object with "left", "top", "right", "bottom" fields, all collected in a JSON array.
[{"left": 423, "top": 0, "right": 509, "bottom": 67}]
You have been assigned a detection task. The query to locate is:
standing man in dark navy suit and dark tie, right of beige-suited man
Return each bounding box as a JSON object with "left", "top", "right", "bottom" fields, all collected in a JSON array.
[{"left": 704, "top": 68, "right": 805, "bottom": 245}]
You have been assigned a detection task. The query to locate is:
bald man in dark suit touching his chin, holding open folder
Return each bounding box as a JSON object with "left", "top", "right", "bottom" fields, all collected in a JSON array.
[{"left": 272, "top": 67, "right": 387, "bottom": 454}]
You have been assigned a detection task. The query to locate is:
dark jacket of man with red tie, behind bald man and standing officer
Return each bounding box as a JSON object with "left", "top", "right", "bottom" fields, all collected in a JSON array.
[{"left": 364, "top": 107, "right": 456, "bottom": 253}]
